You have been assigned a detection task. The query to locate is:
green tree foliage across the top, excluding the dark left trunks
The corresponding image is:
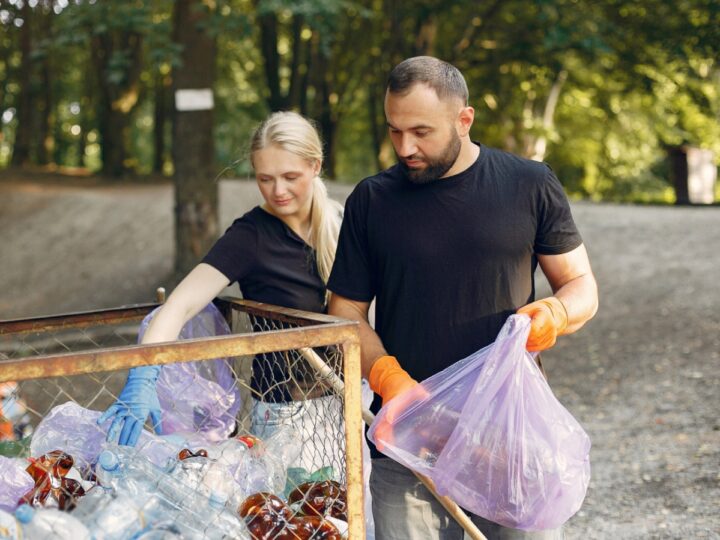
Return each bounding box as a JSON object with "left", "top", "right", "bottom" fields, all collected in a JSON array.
[{"left": 0, "top": 0, "right": 720, "bottom": 202}]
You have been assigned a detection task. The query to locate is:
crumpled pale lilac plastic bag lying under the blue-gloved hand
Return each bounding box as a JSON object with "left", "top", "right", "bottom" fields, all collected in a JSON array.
[{"left": 30, "top": 401, "right": 199, "bottom": 470}]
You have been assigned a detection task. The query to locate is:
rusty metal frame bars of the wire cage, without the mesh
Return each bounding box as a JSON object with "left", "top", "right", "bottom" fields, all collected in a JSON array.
[{"left": 0, "top": 297, "right": 365, "bottom": 538}]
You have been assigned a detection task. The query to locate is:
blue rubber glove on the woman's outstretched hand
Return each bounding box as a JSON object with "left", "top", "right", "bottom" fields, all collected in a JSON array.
[{"left": 97, "top": 366, "right": 162, "bottom": 446}]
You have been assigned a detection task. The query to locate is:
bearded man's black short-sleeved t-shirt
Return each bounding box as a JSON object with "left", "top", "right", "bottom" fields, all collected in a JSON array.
[{"left": 328, "top": 146, "right": 582, "bottom": 452}]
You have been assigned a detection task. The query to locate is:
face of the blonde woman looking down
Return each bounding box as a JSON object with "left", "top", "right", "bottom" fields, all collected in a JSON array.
[{"left": 252, "top": 145, "right": 320, "bottom": 219}]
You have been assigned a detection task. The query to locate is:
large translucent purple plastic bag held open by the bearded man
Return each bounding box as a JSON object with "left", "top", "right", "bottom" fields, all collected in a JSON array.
[{"left": 368, "top": 315, "right": 590, "bottom": 530}]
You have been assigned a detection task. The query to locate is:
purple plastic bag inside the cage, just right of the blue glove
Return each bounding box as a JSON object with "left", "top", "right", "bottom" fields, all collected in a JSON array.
[{"left": 138, "top": 303, "right": 241, "bottom": 441}]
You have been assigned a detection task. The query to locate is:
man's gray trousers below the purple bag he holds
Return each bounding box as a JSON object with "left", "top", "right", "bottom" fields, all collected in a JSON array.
[{"left": 370, "top": 458, "right": 565, "bottom": 540}]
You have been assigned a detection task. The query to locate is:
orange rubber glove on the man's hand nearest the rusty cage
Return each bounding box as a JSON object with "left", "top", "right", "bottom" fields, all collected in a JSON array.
[{"left": 368, "top": 356, "right": 428, "bottom": 452}]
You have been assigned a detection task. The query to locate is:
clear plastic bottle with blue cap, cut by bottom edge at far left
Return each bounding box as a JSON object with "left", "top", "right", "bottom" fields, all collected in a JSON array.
[{"left": 15, "top": 504, "right": 91, "bottom": 540}]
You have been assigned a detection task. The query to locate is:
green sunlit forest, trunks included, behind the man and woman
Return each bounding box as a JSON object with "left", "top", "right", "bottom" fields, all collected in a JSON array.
[{"left": 0, "top": 0, "right": 720, "bottom": 272}]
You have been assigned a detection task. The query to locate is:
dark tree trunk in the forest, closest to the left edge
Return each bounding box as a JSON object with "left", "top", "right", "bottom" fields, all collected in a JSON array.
[{"left": 10, "top": 2, "right": 34, "bottom": 166}]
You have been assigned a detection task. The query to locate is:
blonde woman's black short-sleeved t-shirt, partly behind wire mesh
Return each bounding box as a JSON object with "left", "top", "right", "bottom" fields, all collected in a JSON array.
[{"left": 202, "top": 206, "right": 326, "bottom": 402}]
